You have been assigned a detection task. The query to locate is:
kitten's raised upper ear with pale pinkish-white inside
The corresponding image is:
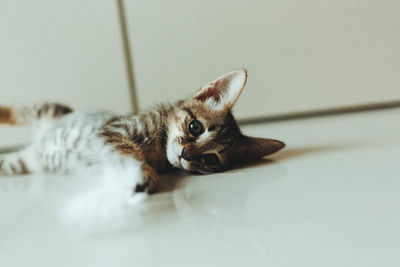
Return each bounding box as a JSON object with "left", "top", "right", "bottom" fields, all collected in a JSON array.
[{"left": 195, "top": 69, "right": 247, "bottom": 110}]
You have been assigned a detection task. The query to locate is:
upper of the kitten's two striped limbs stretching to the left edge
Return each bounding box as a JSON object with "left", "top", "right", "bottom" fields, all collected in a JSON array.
[{"left": 0, "top": 103, "right": 73, "bottom": 125}]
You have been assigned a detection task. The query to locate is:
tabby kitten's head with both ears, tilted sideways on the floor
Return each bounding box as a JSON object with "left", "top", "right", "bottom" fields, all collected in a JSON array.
[{"left": 167, "top": 70, "right": 285, "bottom": 173}]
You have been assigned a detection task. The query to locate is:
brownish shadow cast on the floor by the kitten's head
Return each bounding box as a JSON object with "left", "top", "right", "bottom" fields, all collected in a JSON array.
[{"left": 157, "top": 143, "right": 361, "bottom": 194}]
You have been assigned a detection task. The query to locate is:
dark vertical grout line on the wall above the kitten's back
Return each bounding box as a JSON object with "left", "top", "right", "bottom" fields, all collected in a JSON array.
[{"left": 116, "top": 0, "right": 139, "bottom": 113}]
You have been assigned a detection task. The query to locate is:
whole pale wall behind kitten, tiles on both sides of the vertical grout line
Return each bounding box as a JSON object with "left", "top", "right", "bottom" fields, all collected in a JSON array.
[{"left": 0, "top": 0, "right": 400, "bottom": 125}]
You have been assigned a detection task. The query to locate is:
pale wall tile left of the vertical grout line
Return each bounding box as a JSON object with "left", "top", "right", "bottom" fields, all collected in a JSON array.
[{"left": 0, "top": 0, "right": 131, "bottom": 145}]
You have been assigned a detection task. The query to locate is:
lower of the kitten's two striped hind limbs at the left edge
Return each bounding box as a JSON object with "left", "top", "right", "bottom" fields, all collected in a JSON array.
[{"left": 0, "top": 147, "right": 40, "bottom": 175}]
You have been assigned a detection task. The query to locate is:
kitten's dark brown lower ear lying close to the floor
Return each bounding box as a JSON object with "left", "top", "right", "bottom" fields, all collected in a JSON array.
[{"left": 236, "top": 136, "right": 285, "bottom": 162}]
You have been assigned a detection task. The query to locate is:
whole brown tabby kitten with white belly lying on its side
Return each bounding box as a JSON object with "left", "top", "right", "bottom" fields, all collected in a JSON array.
[{"left": 0, "top": 69, "right": 285, "bottom": 193}]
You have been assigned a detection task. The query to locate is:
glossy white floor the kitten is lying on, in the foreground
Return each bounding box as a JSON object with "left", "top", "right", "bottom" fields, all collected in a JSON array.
[{"left": 0, "top": 109, "right": 400, "bottom": 267}]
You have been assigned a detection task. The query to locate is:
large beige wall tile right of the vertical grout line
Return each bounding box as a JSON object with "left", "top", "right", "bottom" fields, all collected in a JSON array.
[{"left": 125, "top": 0, "right": 400, "bottom": 118}]
